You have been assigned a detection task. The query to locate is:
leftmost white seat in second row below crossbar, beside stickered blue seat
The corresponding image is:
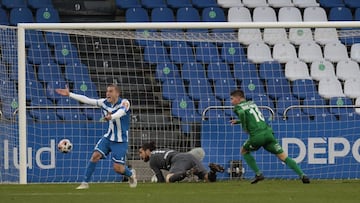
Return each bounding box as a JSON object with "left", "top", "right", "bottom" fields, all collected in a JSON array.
[{"left": 247, "top": 41, "right": 273, "bottom": 63}]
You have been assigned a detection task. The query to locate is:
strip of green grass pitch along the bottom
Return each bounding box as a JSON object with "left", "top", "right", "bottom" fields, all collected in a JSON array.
[{"left": 0, "top": 180, "right": 360, "bottom": 203}]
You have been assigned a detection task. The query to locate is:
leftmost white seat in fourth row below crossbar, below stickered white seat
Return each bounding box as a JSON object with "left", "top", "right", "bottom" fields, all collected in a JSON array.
[{"left": 318, "top": 78, "right": 345, "bottom": 99}]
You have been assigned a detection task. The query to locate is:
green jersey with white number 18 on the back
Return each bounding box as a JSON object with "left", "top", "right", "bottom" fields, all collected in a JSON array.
[{"left": 234, "top": 101, "right": 271, "bottom": 136}]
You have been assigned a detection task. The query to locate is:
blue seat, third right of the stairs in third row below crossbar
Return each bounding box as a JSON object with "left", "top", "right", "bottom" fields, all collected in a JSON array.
[{"left": 207, "top": 62, "right": 233, "bottom": 81}]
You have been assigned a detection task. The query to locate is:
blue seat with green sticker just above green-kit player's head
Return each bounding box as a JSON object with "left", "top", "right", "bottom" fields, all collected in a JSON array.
[{"left": 240, "top": 78, "right": 265, "bottom": 99}]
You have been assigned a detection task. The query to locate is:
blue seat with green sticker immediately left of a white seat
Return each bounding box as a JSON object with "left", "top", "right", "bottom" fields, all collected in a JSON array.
[{"left": 221, "top": 42, "right": 247, "bottom": 64}]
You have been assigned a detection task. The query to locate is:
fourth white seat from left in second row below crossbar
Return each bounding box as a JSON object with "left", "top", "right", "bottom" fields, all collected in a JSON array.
[{"left": 324, "top": 42, "right": 349, "bottom": 63}]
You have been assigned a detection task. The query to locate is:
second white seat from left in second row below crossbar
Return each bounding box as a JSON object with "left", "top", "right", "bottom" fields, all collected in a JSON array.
[{"left": 273, "top": 42, "right": 297, "bottom": 63}]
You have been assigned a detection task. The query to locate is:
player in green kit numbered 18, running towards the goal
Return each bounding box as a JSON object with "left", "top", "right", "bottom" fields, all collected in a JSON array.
[{"left": 230, "top": 90, "right": 310, "bottom": 184}]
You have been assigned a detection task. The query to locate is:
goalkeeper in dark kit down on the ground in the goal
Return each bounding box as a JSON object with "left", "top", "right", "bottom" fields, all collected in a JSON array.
[{"left": 139, "top": 142, "right": 224, "bottom": 183}]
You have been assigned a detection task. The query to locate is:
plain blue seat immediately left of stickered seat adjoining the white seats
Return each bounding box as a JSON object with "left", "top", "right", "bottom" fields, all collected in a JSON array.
[{"left": 195, "top": 42, "right": 221, "bottom": 63}]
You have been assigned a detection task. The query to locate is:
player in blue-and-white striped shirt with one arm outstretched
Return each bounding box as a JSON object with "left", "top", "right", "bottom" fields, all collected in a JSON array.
[{"left": 56, "top": 84, "right": 137, "bottom": 189}]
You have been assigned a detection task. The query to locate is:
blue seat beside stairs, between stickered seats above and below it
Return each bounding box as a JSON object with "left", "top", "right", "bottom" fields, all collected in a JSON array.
[{"left": 162, "top": 79, "right": 186, "bottom": 100}]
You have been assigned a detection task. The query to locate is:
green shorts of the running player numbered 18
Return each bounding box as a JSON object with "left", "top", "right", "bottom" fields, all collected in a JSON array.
[{"left": 243, "top": 130, "right": 284, "bottom": 154}]
